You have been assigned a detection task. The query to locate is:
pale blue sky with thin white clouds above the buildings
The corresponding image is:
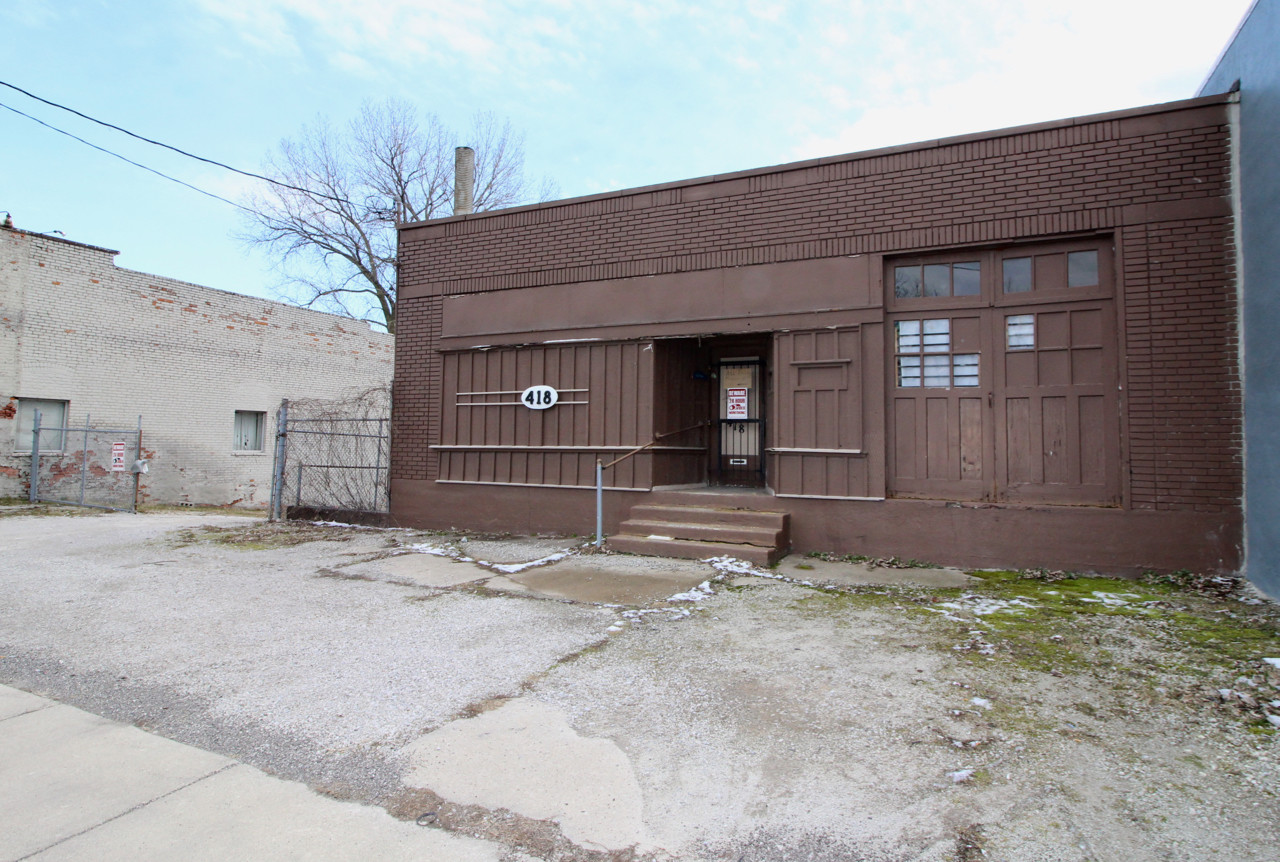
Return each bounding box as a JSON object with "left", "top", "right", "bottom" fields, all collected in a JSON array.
[{"left": 0, "top": 0, "right": 1249, "bottom": 309}]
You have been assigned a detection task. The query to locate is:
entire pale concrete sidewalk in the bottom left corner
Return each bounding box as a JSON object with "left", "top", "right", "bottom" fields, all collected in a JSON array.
[{"left": 0, "top": 685, "right": 504, "bottom": 862}]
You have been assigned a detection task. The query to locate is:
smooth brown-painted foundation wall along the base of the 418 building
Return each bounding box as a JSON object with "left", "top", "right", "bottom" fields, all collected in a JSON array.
[{"left": 392, "top": 480, "right": 1242, "bottom": 575}]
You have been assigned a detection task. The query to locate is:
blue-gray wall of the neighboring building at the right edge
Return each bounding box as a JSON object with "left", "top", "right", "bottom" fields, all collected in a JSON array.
[{"left": 1199, "top": 0, "right": 1280, "bottom": 597}]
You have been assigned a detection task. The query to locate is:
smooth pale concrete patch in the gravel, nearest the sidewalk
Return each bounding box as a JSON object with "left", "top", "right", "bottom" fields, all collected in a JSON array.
[{"left": 404, "top": 698, "right": 644, "bottom": 850}]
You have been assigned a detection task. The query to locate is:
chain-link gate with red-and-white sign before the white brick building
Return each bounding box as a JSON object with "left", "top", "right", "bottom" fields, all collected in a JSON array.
[{"left": 29, "top": 410, "right": 146, "bottom": 512}]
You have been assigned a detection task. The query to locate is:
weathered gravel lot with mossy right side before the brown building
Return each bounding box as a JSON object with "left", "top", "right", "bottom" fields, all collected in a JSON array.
[{"left": 0, "top": 510, "right": 1280, "bottom": 862}]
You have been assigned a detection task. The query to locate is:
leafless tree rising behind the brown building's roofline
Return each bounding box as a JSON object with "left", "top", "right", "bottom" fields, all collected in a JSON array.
[{"left": 242, "top": 100, "right": 554, "bottom": 333}]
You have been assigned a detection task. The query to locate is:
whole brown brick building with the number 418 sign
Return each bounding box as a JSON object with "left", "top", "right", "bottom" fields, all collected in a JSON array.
[{"left": 392, "top": 96, "right": 1242, "bottom": 570}]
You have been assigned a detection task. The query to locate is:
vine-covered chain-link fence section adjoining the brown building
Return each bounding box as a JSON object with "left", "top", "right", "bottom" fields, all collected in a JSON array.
[{"left": 271, "top": 387, "right": 390, "bottom": 519}]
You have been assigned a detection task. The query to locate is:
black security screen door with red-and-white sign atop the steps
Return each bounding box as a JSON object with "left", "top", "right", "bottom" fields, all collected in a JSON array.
[{"left": 712, "top": 357, "right": 764, "bottom": 487}]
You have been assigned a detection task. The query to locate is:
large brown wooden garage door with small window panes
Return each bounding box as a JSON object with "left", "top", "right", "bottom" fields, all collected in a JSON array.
[{"left": 886, "top": 238, "right": 1120, "bottom": 505}]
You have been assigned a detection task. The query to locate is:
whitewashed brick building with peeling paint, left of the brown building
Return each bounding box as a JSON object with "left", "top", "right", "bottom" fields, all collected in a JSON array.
[{"left": 0, "top": 229, "right": 394, "bottom": 506}]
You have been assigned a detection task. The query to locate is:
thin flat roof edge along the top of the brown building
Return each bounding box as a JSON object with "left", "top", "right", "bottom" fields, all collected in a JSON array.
[{"left": 397, "top": 94, "right": 1233, "bottom": 231}]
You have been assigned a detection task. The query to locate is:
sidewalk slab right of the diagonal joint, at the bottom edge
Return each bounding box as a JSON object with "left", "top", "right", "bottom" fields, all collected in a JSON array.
[{"left": 38, "top": 763, "right": 502, "bottom": 862}]
